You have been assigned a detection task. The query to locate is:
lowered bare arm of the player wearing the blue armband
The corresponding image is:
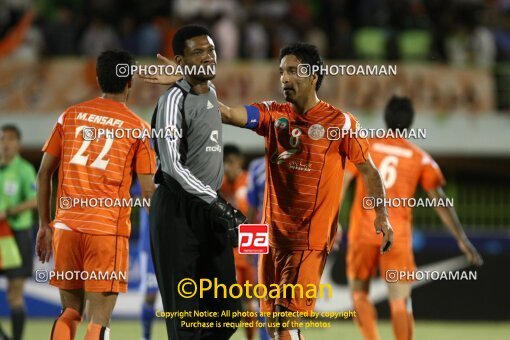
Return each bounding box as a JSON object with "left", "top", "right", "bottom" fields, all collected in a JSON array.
[{"left": 355, "top": 158, "right": 393, "bottom": 254}]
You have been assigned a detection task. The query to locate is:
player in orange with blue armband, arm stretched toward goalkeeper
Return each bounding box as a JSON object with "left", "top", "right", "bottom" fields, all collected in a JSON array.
[{"left": 220, "top": 43, "right": 393, "bottom": 339}]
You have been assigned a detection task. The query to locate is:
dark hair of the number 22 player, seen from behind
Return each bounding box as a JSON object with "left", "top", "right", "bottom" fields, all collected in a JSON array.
[{"left": 96, "top": 50, "right": 135, "bottom": 94}]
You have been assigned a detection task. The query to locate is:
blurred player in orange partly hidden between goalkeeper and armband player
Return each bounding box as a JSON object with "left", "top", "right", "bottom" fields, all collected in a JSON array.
[{"left": 220, "top": 144, "right": 257, "bottom": 340}]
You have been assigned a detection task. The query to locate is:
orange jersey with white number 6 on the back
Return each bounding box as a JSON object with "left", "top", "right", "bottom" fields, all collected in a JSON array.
[{"left": 347, "top": 138, "right": 445, "bottom": 244}]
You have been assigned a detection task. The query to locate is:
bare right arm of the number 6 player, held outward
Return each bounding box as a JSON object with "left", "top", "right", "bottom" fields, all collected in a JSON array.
[{"left": 427, "top": 187, "right": 483, "bottom": 266}]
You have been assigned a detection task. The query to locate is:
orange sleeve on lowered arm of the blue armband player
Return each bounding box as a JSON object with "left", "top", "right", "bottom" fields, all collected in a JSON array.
[{"left": 340, "top": 112, "right": 369, "bottom": 164}]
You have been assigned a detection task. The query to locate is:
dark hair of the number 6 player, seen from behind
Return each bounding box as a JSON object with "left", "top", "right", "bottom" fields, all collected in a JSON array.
[{"left": 384, "top": 96, "right": 414, "bottom": 131}]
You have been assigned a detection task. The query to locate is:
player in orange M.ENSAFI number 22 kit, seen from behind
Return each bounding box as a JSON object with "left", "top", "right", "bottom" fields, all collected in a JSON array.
[{"left": 36, "top": 51, "right": 156, "bottom": 340}]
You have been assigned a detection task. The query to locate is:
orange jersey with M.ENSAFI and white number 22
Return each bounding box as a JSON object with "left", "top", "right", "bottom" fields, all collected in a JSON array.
[{"left": 42, "top": 98, "right": 156, "bottom": 236}]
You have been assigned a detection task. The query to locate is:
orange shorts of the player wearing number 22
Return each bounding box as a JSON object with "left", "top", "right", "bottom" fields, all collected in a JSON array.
[{"left": 50, "top": 229, "right": 129, "bottom": 293}]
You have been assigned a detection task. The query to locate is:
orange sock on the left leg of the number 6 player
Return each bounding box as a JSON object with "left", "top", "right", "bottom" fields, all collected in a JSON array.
[{"left": 352, "top": 292, "right": 379, "bottom": 340}]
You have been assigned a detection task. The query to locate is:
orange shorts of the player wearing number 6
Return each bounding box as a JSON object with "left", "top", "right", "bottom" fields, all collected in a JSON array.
[{"left": 347, "top": 241, "right": 416, "bottom": 282}]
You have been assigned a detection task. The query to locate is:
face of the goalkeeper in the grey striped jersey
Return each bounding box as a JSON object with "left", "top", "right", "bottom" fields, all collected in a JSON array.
[{"left": 178, "top": 35, "right": 216, "bottom": 81}]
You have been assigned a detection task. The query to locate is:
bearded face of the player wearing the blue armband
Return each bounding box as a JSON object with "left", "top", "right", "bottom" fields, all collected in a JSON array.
[{"left": 280, "top": 54, "right": 317, "bottom": 103}]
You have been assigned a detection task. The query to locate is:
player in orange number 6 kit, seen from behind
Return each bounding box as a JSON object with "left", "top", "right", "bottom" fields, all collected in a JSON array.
[{"left": 343, "top": 97, "right": 483, "bottom": 340}]
